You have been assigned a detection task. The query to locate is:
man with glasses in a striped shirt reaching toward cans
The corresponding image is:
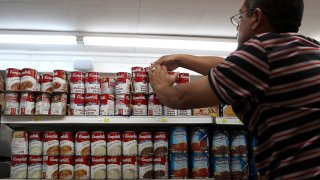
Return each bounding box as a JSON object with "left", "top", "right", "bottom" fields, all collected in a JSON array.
[{"left": 149, "top": 0, "right": 320, "bottom": 179}]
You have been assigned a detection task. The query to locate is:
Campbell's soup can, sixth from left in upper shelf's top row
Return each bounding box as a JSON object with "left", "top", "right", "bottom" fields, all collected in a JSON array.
[{"left": 85, "top": 72, "right": 101, "bottom": 94}]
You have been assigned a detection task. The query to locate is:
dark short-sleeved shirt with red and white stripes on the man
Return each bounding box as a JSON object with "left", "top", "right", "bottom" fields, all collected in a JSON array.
[{"left": 209, "top": 33, "right": 320, "bottom": 179}]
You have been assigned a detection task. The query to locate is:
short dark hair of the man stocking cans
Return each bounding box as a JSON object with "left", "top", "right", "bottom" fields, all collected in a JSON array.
[{"left": 245, "top": 0, "right": 304, "bottom": 33}]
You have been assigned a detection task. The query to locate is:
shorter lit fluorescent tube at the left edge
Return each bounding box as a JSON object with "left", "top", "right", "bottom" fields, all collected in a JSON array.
[{"left": 0, "top": 34, "right": 77, "bottom": 44}]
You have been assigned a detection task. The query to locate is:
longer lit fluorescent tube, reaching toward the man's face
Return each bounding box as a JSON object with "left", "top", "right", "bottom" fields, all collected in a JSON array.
[{"left": 83, "top": 36, "right": 237, "bottom": 51}]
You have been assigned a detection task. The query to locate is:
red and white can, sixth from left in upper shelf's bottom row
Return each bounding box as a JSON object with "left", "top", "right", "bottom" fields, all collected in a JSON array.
[{"left": 84, "top": 94, "right": 100, "bottom": 116}]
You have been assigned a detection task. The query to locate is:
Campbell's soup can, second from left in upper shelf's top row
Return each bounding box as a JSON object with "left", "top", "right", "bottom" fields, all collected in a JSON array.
[{"left": 20, "top": 68, "right": 38, "bottom": 91}]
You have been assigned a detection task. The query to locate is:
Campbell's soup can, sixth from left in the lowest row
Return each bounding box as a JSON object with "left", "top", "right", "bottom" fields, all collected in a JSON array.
[{"left": 91, "top": 156, "right": 107, "bottom": 179}]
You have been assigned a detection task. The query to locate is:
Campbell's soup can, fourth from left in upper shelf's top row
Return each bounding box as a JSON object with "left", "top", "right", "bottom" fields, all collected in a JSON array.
[{"left": 52, "top": 70, "right": 68, "bottom": 92}]
